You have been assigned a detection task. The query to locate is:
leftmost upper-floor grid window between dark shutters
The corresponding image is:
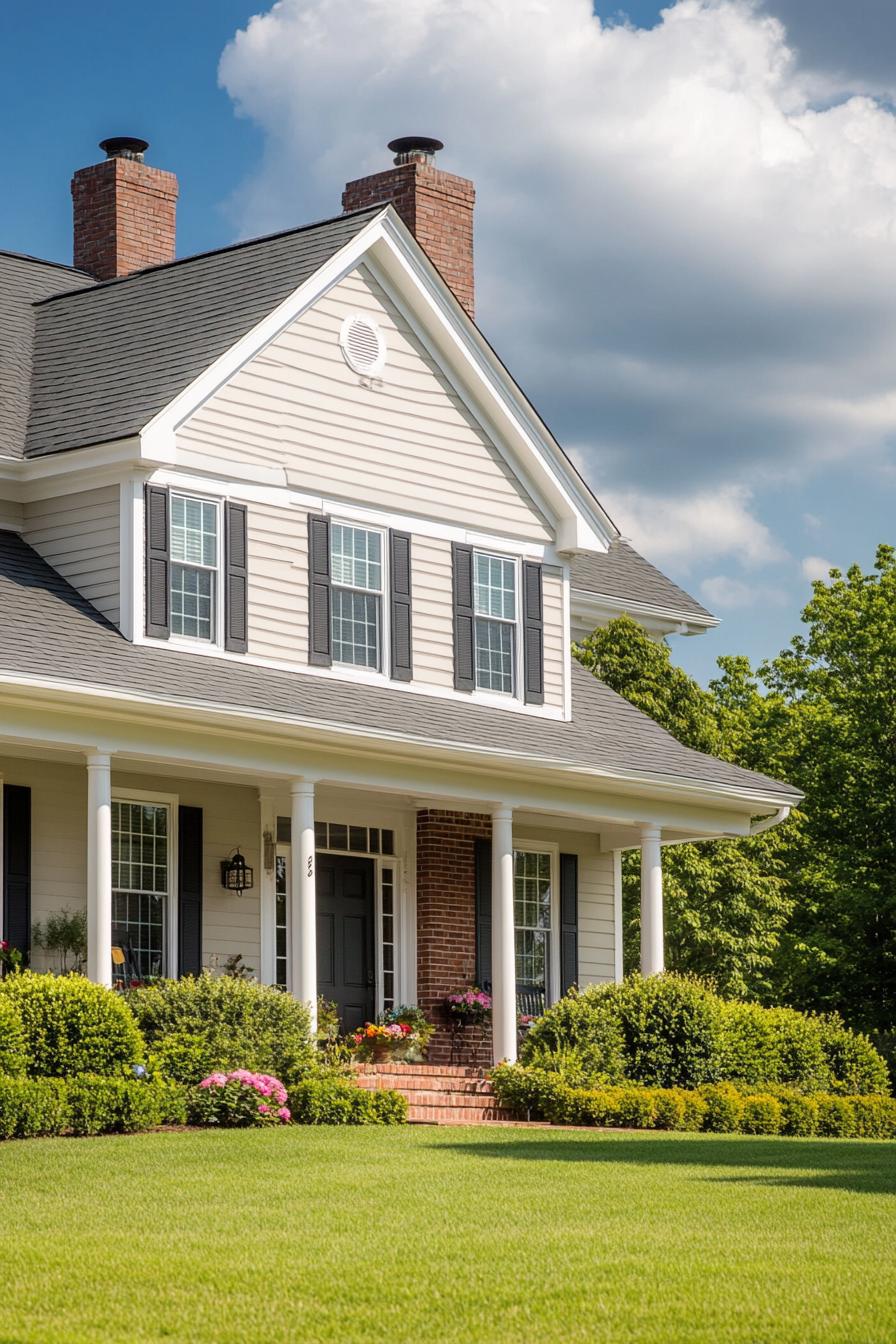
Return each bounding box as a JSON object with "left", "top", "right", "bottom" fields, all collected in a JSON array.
[{"left": 171, "top": 495, "right": 219, "bottom": 640}]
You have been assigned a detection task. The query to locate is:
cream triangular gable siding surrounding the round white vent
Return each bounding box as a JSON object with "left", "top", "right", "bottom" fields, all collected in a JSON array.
[{"left": 179, "top": 267, "right": 551, "bottom": 540}]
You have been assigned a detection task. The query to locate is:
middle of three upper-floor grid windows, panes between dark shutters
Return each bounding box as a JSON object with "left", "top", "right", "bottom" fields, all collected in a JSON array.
[{"left": 330, "top": 523, "right": 383, "bottom": 671}]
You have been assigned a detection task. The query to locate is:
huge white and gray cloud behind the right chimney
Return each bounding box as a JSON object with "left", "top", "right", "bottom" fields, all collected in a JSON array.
[{"left": 220, "top": 0, "right": 896, "bottom": 564}]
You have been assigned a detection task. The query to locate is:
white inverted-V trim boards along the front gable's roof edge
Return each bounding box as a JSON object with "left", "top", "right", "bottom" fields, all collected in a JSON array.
[{"left": 141, "top": 207, "right": 618, "bottom": 551}]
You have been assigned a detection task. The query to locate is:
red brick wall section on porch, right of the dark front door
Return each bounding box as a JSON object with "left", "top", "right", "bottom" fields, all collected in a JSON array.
[{"left": 416, "top": 810, "right": 492, "bottom": 1066}]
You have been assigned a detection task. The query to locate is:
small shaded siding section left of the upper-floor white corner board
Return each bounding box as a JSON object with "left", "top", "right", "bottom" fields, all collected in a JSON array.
[{"left": 24, "top": 485, "right": 121, "bottom": 624}]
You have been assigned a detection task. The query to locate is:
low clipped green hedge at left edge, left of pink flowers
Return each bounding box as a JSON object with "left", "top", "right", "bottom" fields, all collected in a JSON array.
[{"left": 0, "top": 1074, "right": 187, "bottom": 1138}]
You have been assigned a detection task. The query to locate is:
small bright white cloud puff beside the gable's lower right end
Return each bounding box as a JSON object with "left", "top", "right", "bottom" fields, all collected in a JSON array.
[{"left": 603, "top": 485, "right": 787, "bottom": 570}]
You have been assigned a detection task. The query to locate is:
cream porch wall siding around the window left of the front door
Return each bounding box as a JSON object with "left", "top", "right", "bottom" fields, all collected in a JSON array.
[{"left": 0, "top": 757, "right": 261, "bottom": 972}]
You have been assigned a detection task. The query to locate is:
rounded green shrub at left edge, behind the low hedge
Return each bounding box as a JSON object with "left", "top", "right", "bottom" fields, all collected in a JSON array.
[{"left": 0, "top": 970, "right": 145, "bottom": 1078}]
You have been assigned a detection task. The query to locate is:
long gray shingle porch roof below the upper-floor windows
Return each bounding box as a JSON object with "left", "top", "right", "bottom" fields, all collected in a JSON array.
[{"left": 0, "top": 532, "right": 799, "bottom": 802}]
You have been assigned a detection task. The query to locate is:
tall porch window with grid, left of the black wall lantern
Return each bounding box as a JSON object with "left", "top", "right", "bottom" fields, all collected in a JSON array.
[{"left": 111, "top": 802, "right": 171, "bottom": 980}]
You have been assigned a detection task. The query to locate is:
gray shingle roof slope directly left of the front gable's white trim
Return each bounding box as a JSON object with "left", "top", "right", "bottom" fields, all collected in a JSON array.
[{"left": 26, "top": 206, "right": 383, "bottom": 457}]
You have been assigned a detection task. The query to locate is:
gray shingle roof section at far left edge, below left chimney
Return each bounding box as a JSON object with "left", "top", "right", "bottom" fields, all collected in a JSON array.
[{"left": 0, "top": 251, "right": 94, "bottom": 457}]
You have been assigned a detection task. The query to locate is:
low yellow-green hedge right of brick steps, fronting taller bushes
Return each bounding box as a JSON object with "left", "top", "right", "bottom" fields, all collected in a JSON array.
[{"left": 492, "top": 1064, "right": 896, "bottom": 1138}]
